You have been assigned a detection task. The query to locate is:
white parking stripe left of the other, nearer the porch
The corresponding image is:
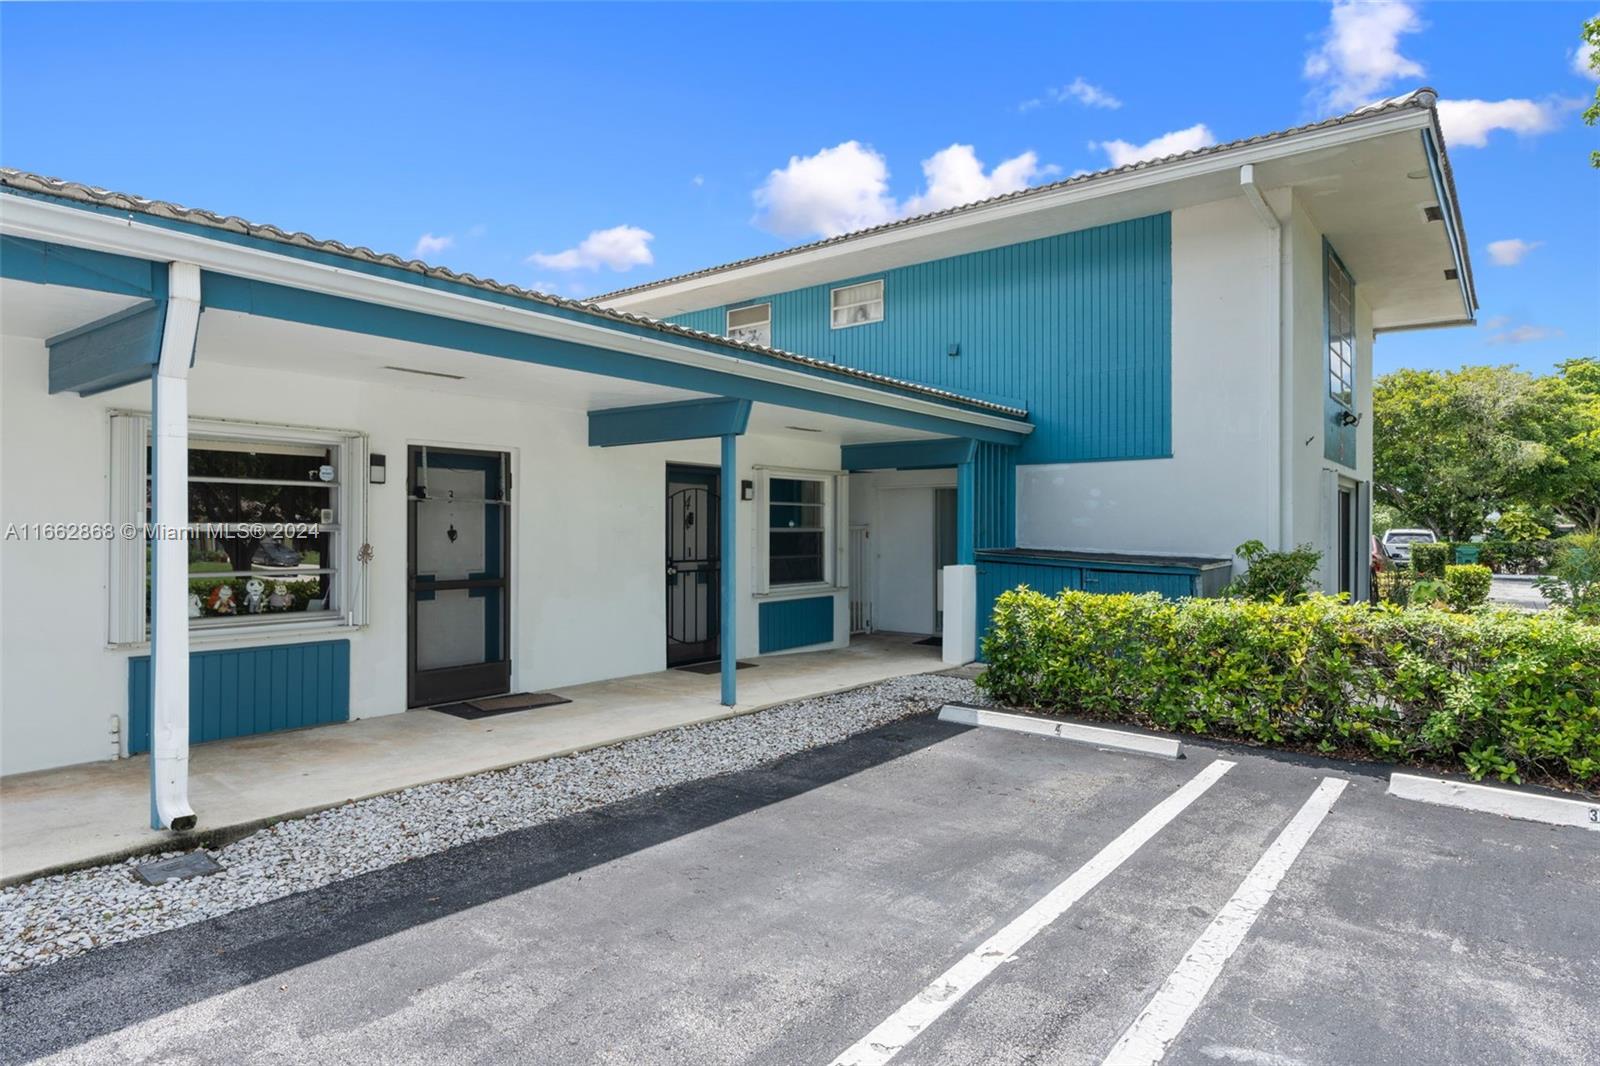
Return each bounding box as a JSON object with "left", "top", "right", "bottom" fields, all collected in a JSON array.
[{"left": 832, "top": 759, "right": 1234, "bottom": 1066}]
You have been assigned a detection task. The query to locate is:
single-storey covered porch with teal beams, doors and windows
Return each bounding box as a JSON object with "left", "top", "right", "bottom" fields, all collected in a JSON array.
[{"left": 0, "top": 174, "right": 1030, "bottom": 845}]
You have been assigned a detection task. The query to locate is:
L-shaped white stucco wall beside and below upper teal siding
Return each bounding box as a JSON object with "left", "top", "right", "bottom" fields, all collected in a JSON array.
[{"left": 1018, "top": 198, "right": 1278, "bottom": 557}]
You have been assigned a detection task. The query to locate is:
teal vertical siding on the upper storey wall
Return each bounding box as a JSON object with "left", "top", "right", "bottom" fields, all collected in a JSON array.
[{"left": 674, "top": 214, "right": 1173, "bottom": 464}]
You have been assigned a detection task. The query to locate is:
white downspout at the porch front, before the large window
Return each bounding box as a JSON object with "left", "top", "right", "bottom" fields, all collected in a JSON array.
[{"left": 150, "top": 262, "right": 200, "bottom": 831}]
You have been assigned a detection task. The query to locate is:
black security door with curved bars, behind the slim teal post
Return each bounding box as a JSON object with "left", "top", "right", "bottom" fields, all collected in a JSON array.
[{"left": 667, "top": 466, "right": 722, "bottom": 666}]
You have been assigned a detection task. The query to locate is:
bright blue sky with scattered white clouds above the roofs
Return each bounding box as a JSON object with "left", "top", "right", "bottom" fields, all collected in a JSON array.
[{"left": 0, "top": 3, "right": 1600, "bottom": 371}]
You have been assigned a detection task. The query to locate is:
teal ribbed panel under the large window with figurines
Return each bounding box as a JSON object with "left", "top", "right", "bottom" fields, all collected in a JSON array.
[{"left": 128, "top": 640, "right": 350, "bottom": 754}]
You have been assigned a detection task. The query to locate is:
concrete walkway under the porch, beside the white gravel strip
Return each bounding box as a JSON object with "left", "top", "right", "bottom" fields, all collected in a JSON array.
[{"left": 0, "top": 634, "right": 944, "bottom": 884}]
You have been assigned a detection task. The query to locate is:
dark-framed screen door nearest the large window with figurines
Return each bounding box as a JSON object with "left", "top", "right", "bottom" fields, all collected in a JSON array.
[{"left": 406, "top": 448, "right": 510, "bottom": 707}]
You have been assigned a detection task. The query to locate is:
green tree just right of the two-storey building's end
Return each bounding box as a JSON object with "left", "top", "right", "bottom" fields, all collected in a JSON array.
[{"left": 1373, "top": 367, "right": 1549, "bottom": 539}]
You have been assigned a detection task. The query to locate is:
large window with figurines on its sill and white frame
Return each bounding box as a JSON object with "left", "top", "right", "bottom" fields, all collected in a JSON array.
[{"left": 112, "top": 413, "right": 365, "bottom": 643}]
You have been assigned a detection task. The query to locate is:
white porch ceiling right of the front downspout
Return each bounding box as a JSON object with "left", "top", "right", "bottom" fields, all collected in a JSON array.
[{"left": 195, "top": 309, "right": 936, "bottom": 443}]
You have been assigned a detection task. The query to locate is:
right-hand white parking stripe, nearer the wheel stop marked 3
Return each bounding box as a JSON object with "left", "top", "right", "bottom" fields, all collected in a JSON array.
[{"left": 1104, "top": 778, "right": 1347, "bottom": 1066}]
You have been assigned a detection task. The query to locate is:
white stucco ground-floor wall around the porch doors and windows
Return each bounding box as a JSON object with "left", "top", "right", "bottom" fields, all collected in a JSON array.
[{"left": 0, "top": 336, "right": 848, "bottom": 773}]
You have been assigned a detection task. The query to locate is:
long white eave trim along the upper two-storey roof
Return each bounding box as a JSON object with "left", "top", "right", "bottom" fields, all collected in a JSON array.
[{"left": 603, "top": 107, "right": 1432, "bottom": 311}]
